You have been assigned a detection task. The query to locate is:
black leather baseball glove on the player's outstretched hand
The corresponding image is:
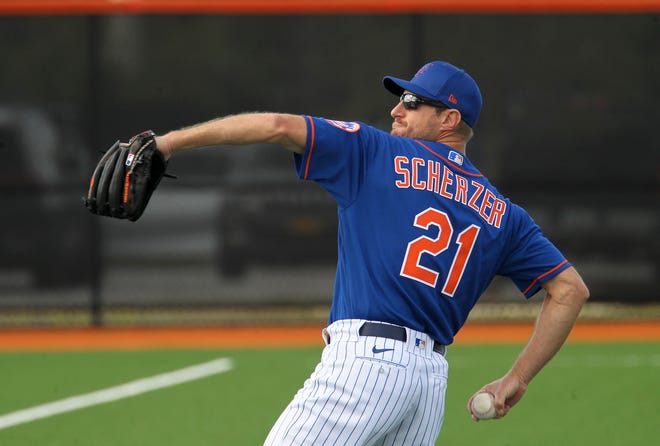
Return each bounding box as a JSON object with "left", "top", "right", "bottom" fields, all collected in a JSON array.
[{"left": 85, "top": 130, "right": 170, "bottom": 221}]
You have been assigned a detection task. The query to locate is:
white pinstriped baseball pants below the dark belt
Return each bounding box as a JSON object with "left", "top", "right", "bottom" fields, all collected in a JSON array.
[{"left": 264, "top": 319, "right": 448, "bottom": 446}]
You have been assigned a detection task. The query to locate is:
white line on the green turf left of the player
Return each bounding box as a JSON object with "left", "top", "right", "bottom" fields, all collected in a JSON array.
[{"left": 0, "top": 358, "right": 233, "bottom": 430}]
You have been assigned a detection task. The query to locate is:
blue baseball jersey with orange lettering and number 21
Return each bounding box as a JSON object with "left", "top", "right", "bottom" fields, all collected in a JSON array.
[{"left": 294, "top": 116, "right": 570, "bottom": 345}]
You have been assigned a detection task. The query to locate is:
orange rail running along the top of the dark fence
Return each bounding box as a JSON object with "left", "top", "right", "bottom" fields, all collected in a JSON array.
[{"left": 0, "top": 0, "right": 660, "bottom": 15}]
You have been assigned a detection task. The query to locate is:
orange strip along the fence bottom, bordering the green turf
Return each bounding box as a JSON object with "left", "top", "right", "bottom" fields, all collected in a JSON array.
[{"left": 0, "top": 321, "right": 660, "bottom": 351}]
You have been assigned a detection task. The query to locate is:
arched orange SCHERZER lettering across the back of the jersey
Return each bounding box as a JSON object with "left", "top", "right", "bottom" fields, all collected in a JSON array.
[{"left": 394, "top": 156, "right": 506, "bottom": 228}]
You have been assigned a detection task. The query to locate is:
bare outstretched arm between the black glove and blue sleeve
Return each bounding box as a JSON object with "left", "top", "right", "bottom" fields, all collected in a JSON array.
[{"left": 156, "top": 113, "right": 307, "bottom": 157}]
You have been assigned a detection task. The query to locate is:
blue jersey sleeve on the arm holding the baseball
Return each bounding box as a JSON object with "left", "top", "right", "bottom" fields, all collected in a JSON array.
[{"left": 498, "top": 205, "right": 571, "bottom": 298}]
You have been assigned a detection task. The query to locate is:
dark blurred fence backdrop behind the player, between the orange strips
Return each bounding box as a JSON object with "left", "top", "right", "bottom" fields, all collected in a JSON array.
[{"left": 0, "top": 1, "right": 660, "bottom": 326}]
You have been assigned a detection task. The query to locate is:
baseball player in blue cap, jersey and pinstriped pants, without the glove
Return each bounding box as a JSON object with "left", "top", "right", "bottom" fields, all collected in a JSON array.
[{"left": 148, "top": 61, "right": 588, "bottom": 446}]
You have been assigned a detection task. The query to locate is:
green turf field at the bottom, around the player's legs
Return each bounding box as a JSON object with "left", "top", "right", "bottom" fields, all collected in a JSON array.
[{"left": 0, "top": 343, "right": 660, "bottom": 446}]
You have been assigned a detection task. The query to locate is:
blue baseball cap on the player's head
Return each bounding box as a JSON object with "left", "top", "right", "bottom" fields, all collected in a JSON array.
[{"left": 383, "top": 61, "right": 482, "bottom": 127}]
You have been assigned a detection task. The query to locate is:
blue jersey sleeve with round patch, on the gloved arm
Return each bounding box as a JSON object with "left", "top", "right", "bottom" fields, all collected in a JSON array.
[{"left": 294, "top": 116, "right": 376, "bottom": 207}]
